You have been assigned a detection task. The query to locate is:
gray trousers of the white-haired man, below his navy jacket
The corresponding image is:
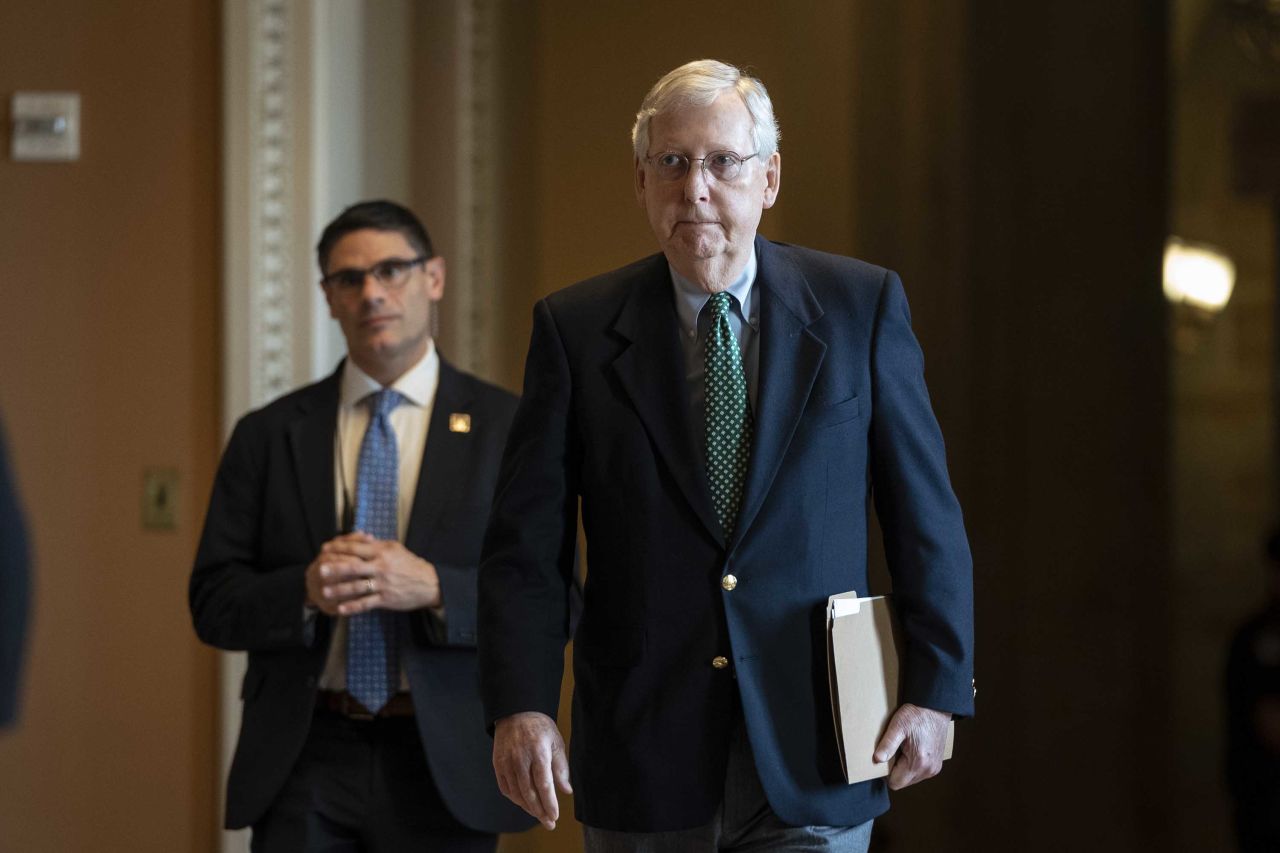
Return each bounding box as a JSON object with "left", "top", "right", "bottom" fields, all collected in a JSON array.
[{"left": 582, "top": 721, "right": 872, "bottom": 853}]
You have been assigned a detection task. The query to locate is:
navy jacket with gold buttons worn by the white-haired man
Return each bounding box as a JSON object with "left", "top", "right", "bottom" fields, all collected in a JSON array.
[{"left": 479, "top": 238, "right": 973, "bottom": 831}]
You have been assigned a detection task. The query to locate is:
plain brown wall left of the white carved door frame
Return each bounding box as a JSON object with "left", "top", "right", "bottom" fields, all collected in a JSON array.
[{"left": 0, "top": 0, "right": 220, "bottom": 852}]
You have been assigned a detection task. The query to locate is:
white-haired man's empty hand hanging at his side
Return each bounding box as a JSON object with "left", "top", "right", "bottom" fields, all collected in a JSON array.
[{"left": 493, "top": 711, "right": 573, "bottom": 830}]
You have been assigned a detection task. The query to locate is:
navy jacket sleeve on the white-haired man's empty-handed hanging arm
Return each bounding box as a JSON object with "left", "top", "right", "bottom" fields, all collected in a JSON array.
[{"left": 477, "top": 300, "right": 577, "bottom": 727}]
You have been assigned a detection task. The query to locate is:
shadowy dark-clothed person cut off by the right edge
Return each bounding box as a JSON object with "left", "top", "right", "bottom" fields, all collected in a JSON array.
[{"left": 1226, "top": 528, "right": 1280, "bottom": 853}]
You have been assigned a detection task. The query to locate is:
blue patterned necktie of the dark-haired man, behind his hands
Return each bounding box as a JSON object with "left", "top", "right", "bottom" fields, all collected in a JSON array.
[{"left": 347, "top": 388, "right": 404, "bottom": 713}]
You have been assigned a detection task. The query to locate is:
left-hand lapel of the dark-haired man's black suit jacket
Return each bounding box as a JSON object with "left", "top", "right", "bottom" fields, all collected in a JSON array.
[{"left": 288, "top": 365, "right": 342, "bottom": 552}]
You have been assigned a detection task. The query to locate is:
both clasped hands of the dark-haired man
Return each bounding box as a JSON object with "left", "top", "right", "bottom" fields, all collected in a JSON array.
[{"left": 306, "top": 533, "right": 443, "bottom": 616}]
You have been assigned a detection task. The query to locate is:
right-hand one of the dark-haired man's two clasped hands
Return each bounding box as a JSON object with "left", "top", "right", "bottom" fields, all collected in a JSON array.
[{"left": 316, "top": 533, "right": 443, "bottom": 616}]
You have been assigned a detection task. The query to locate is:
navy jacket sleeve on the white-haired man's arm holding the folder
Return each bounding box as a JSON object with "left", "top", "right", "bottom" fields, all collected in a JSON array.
[{"left": 870, "top": 273, "right": 974, "bottom": 716}]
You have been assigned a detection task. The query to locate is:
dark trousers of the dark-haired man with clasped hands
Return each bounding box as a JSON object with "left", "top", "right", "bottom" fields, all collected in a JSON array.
[{"left": 251, "top": 711, "right": 498, "bottom": 853}]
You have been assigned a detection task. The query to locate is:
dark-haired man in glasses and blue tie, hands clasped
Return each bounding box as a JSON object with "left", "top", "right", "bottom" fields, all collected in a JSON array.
[{"left": 189, "top": 201, "right": 531, "bottom": 853}]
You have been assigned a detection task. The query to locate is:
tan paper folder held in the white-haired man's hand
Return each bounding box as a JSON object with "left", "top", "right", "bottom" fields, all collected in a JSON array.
[{"left": 827, "top": 592, "right": 955, "bottom": 784}]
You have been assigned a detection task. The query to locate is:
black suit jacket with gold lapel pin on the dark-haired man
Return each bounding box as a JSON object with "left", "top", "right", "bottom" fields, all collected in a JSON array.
[{"left": 189, "top": 360, "right": 532, "bottom": 833}]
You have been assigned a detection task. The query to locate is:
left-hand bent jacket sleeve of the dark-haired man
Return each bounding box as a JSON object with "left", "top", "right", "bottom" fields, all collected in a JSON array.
[{"left": 188, "top": 419, "right": 315, "bottom": 651}]
